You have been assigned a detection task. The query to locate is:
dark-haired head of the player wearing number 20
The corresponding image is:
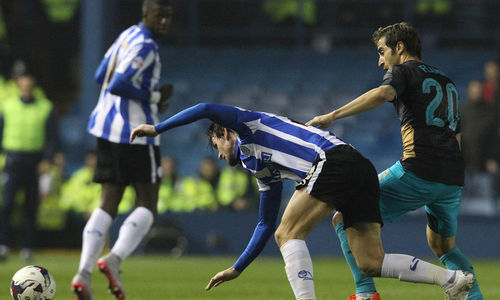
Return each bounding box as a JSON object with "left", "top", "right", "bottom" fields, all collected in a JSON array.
[{"left": 372, "top": 22, "right": 422, "bottom": 70}]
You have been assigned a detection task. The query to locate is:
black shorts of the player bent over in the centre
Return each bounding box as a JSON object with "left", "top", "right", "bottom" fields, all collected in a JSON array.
[{"left": 297, "top": 145, "right": 383, "bottom": 229}]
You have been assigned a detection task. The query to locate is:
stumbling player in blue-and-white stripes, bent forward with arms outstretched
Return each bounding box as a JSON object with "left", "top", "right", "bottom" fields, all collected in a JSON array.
[{"left": 130, "top": 103, "right": 474, "bottom": 299}]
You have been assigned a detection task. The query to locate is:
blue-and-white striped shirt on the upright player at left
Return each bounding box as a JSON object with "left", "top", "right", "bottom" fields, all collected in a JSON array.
[{"left": 87, "top": 23, "right": 161, "bottom": 145}]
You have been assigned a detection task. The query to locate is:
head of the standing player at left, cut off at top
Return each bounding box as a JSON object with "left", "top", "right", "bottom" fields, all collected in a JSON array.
[{"left": 142, "top": 0, "right": 173, "bottom": 37}]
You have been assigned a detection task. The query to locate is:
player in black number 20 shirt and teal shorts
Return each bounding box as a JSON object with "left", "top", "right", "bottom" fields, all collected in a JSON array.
[{"left": 306, "top": 23, "right": 483, "bottom": 300}]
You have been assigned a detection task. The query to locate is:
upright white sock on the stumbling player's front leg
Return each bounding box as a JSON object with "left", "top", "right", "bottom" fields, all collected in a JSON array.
[{"left": 280, "top": 240, "right": 316, "bottom": 300}]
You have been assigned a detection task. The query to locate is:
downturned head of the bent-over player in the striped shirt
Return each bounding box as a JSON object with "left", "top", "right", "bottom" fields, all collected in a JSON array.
[{"left": 207, "top": 123, "right": 238, "bottom": 166}]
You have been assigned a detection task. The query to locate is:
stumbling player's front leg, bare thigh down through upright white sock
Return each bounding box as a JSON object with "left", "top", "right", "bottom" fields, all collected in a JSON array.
[{"left": 275, "top": 190, "right": 334, "bottom": 299}]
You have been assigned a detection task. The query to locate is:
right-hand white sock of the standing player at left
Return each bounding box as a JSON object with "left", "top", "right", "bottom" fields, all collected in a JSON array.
[{"left": 111, "top": 207, "right": 154, "bottom": 261}]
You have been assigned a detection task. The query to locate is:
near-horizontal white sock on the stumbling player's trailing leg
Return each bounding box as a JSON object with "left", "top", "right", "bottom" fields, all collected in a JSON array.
[{"left": 381, "top": 254, "right": 455, "bottom": 287}]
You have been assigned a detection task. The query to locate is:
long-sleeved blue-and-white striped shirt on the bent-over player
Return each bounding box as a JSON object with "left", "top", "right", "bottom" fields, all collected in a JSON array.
[{"left": 155, "top": 103, "right": 346, "bottom": 272}]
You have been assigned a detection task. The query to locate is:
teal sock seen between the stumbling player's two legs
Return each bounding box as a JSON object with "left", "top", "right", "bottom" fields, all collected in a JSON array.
[{"left": 335, "top": 222, "right": 377, "bottom": 294}]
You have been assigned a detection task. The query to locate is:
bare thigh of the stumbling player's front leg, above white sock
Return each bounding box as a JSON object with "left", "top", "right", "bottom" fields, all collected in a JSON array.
[{"left": 276, "top": 188, "right": 334, "bottom": 247}]
